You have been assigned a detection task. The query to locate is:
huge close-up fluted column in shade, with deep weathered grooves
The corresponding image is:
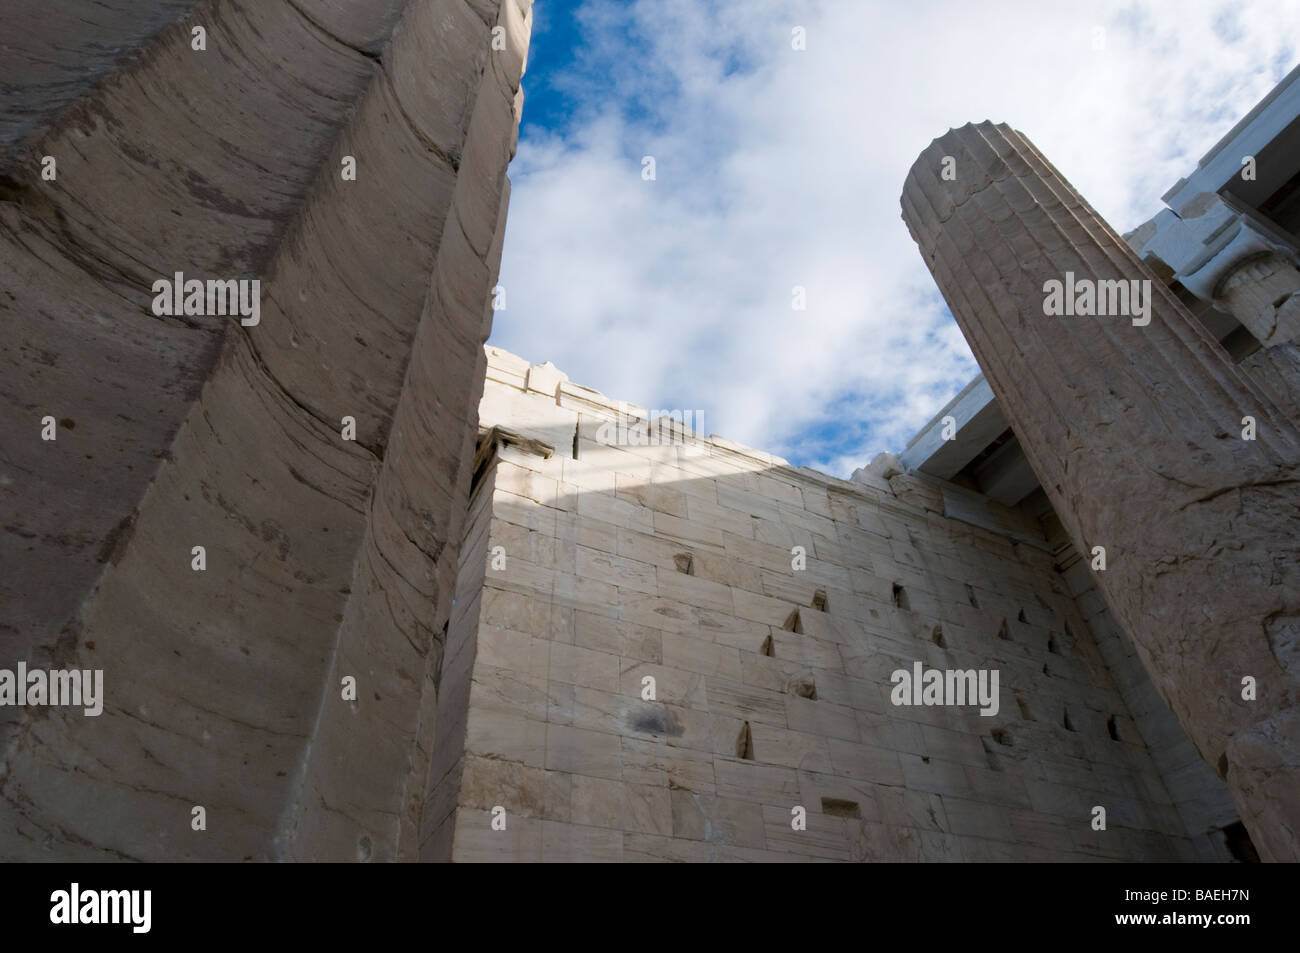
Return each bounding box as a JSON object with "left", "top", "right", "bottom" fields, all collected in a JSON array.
[{"left": 0, "top": 0, "right": 530, "bottom": 861}]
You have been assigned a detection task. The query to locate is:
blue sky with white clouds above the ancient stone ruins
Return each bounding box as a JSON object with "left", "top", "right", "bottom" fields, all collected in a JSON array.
[{"left": 491, "top": 0, "right": 1300, "bottom": 477}]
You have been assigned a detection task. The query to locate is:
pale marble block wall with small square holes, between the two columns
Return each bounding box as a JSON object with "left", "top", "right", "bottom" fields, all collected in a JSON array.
[{"left": 421, "top": 348, "right": 1196, "bottom": 861}]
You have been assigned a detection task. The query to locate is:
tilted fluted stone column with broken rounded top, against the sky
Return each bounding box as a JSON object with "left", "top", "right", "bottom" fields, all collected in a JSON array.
[{"left": 902, "top": 122, "right": 1300, "bottom": 861}]
